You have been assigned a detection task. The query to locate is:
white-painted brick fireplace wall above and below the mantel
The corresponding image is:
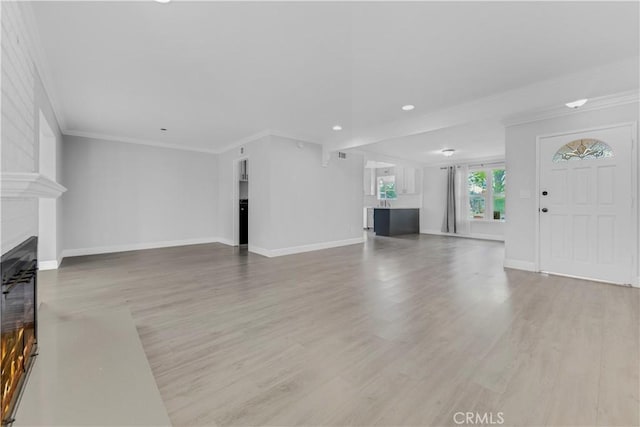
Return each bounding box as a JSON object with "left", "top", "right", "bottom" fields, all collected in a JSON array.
[{"left": 0, "top": 1, "right": 62, "bottom": 259}]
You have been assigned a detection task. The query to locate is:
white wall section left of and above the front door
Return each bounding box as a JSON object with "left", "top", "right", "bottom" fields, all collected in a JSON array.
[{"left": 505, "top": 104, "right": 638, "bottom": 269}]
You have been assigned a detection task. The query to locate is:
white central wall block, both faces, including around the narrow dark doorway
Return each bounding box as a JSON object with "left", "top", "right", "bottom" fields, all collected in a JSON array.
[{"left": 218, "top": 136, "right": 363, "bottom": 256}]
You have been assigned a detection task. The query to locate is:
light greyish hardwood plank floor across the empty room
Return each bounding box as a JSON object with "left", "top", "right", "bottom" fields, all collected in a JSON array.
[{"left": 40, "top": 235, "right": 640, "bottom": 426}]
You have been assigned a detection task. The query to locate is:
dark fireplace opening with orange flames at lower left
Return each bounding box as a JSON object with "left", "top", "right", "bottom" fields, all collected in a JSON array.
[{"left": 0, "top": 236, "right": 38, "bottom": 425}]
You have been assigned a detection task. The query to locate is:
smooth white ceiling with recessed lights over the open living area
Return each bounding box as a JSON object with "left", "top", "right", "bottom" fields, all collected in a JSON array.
[{"left": 33, "top": 0, "right": 639, "bottom": 158}]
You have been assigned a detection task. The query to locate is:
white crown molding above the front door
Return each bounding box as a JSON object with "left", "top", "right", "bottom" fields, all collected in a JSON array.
[{"left": 502, "top": 90, "right": 640, "bottom": 127}]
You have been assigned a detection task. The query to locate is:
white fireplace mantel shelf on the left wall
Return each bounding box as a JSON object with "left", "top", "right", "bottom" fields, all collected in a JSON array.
[{"left": 0, "top": 172, "right": 67, "bottom": 199}]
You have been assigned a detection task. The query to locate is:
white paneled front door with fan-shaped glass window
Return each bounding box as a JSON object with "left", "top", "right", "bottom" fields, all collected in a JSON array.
[{"left": 538, "top": 125, "right": 635, "bottom": 284}]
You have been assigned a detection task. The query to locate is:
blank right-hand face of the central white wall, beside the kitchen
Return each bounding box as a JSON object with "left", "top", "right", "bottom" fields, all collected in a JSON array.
[{"left": 266, "top": 137, "right": 364, "bottom": 250}]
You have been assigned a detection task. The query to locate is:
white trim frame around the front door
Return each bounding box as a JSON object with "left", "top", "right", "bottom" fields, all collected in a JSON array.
[{"left": 535, "top": 122, "right": 640, "bottom": 286}]
